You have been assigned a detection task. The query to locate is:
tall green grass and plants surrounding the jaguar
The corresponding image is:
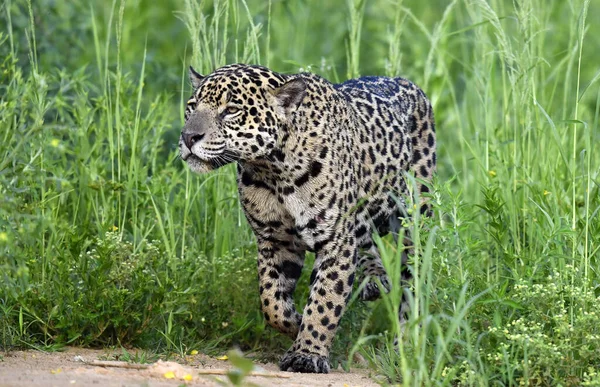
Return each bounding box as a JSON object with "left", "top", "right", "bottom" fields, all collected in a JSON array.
[{"left": 0, "top": 0, "right": 600, "bottom": 386}]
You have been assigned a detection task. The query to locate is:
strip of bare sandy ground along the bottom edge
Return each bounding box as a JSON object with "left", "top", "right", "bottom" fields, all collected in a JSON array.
[{"left": 0, "top": 348, "right": 379, "bottom": 387}]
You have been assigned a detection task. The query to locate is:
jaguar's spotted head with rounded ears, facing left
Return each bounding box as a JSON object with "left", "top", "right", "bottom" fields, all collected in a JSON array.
[{"left": 179, "top": 64, "right": 306, "bottom": 173}]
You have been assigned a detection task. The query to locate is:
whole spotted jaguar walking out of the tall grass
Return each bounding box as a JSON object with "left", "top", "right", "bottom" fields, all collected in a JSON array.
[{"left": 179, "top": 64, "right": 436, "bottom": 373}]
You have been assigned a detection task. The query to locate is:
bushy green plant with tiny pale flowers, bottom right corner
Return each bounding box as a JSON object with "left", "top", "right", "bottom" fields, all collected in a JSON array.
[{"left": 482, "top": 264, "right": 600, "bottom": 385}]
